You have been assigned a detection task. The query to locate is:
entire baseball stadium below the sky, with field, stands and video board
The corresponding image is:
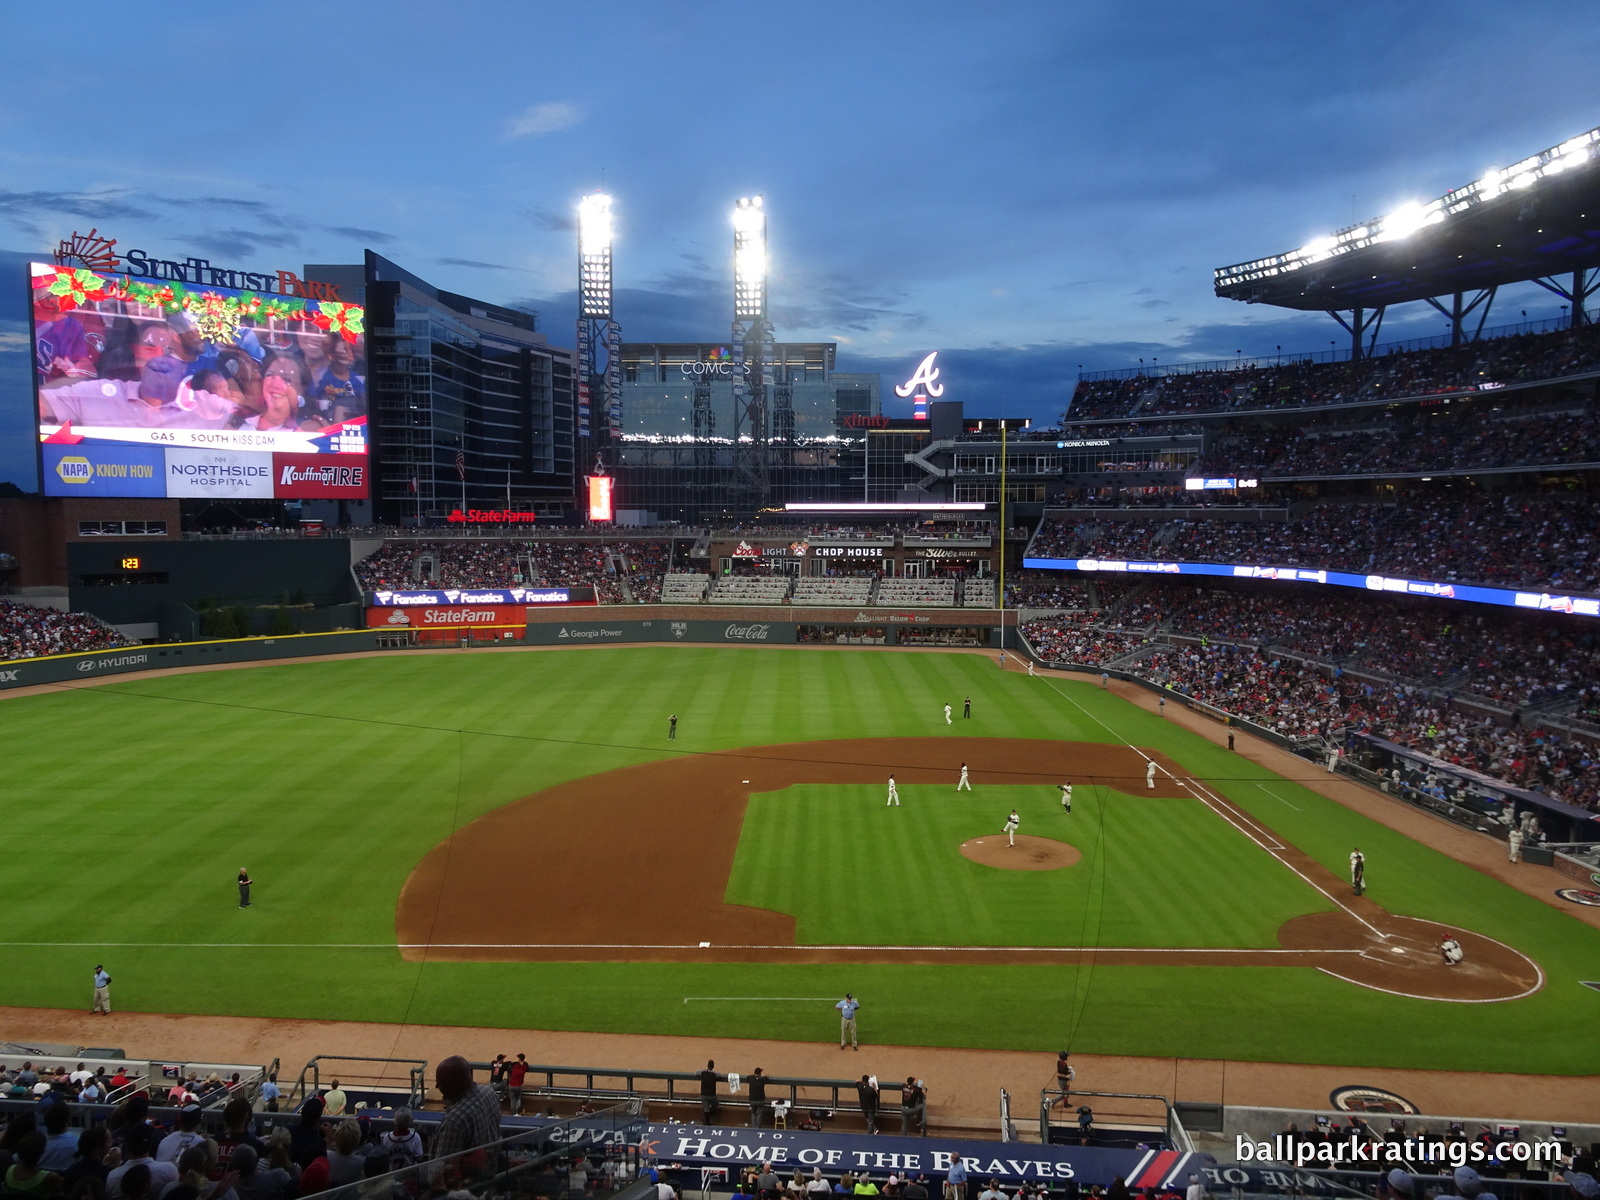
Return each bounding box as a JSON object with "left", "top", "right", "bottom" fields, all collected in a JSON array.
[{"left": 0, "top": 96, "right": 1600, "bottom": 1200}]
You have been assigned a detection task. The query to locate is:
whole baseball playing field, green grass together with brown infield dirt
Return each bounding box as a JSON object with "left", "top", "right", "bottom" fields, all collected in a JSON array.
[{"left": 0, "top": 646, "right": 1600, "bottom": 1075}]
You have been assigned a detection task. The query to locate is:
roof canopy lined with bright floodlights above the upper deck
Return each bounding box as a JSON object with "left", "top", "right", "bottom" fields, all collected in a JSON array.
[{"left": 1214, "top": 130, "right": 1600, "bottom": 312}]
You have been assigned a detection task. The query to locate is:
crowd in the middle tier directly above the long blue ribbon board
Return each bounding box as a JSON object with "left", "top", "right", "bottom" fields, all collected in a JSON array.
[{"left": 1029, "top": 496, "right": 1600, "bottom": 592}]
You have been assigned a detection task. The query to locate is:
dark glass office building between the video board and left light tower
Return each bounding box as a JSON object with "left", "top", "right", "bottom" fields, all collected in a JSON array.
[{"left": 332, "top": 251, "right": 578, "bottom": 525}]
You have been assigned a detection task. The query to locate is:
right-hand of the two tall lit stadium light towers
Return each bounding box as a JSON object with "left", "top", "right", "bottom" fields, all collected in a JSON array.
[{"left": 733, "top": 195, "right": 774, "bottom": 504}]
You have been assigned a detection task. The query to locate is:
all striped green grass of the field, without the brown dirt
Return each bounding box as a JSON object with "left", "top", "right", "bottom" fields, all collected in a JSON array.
[{"left": 0, "top": 646, "right": 1600, "bottom": 1074}]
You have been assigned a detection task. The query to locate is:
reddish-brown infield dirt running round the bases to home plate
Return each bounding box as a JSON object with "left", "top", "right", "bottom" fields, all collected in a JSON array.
[{"left": 395, "top": 738, "right": 1544, "bottom": 1002}]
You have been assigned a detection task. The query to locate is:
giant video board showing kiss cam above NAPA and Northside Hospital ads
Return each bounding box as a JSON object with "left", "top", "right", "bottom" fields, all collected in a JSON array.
[{"left": 29, "top": 262, "right": 370, "bottom": 499}]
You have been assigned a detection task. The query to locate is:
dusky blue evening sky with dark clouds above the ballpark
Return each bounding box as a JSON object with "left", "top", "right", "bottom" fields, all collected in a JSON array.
[{"left": 0, "top": 0, "right": 1600, "bottom": 432}]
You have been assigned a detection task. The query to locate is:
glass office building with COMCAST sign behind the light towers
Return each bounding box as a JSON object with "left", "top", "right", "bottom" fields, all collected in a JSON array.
[{"left": 606, "top": 341, "right": 880, "bottom": 522}]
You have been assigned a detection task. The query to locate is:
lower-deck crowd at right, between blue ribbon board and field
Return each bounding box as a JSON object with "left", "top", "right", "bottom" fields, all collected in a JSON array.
[{"left": 1024, "top": 582, "right": 1600, "bottom": 810}]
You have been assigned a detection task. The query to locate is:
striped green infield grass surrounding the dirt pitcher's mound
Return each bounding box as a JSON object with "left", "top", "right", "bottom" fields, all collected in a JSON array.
[{"left": 726, "top": 778, "right": 1333, "bottom": 949}]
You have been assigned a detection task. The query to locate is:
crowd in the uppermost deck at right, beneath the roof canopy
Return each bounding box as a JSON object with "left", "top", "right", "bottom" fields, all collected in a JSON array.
[{"left": 1064, "top": 325, "right": 1600, "bottom": 421}]
